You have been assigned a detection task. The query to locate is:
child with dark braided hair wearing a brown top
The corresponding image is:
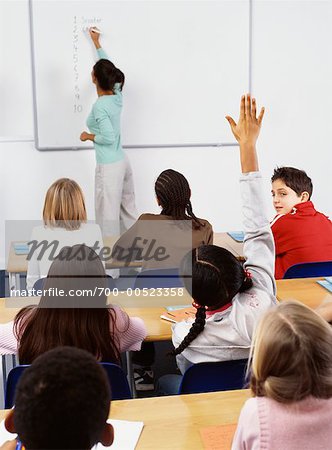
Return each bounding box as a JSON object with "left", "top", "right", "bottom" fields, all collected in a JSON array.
[{"left": 113, "top": 169, "right": 213, "bottom": 269}]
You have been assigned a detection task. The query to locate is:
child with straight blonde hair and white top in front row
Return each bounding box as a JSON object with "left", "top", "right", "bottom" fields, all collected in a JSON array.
[{"left": 27, "top": 178, "right": 103, "bottom": 290}]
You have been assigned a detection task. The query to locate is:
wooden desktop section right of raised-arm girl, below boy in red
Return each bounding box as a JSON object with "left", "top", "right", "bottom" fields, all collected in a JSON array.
[{"left": 276, "top": 278, "right": 332, "bottom": 309}]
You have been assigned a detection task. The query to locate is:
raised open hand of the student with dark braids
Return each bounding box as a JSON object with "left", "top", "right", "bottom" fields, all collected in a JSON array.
[{"left": 226, "top": 94, "right": 265, "bottom": 145}]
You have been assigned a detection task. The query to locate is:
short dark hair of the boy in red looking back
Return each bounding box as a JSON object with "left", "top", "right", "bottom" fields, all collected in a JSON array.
[{"left": 271, "top": 167, "right": 313, "bottom": 200}]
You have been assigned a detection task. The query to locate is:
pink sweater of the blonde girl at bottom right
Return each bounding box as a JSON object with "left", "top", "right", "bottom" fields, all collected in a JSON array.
[{"left": 232, "top": 396, "right": 332, "bottom": 450}]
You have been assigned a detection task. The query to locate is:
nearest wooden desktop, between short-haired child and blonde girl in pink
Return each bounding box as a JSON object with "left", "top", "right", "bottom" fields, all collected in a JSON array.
[{"left": 0, "top": 390, "right": 250, "bottom": 450}]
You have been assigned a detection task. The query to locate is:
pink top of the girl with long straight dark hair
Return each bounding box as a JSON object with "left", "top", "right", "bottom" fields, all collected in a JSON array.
[{"left": 0, "top": 306, "right": 147, "bottom": 355}]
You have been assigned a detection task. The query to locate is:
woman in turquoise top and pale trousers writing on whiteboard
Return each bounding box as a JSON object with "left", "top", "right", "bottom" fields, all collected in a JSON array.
[{"left": 80, "top": 28, "right": 137, "bottom": 236}]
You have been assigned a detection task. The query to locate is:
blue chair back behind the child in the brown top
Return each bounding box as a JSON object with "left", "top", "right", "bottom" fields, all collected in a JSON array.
[{"left": 135, "top": 268, "right": 183, "bottom": 289}]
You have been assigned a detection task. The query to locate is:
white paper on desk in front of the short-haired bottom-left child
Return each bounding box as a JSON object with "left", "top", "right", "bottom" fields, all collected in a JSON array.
[{"left": 0, "top": 419, "right": 144, "bottom": 450}]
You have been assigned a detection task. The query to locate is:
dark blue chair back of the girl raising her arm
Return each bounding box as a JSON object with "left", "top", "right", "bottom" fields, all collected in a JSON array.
[{"left": 179, "top": 359, "right": 248, "bottom": 394}]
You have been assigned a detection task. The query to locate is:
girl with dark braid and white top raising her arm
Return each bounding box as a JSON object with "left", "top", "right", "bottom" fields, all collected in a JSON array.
[{"left": 173, "top": 95, "right": 276, "bottom": 372}]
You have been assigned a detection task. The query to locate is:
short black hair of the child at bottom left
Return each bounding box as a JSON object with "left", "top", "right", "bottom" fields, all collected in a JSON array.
[{"left": 14, "top": 347, "right": 111, "bottom": 449}]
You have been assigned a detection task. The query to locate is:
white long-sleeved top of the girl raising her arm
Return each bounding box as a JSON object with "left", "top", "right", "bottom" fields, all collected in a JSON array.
[{"left": 172, "top": 172, "right": 277, "bottom": 373}]
